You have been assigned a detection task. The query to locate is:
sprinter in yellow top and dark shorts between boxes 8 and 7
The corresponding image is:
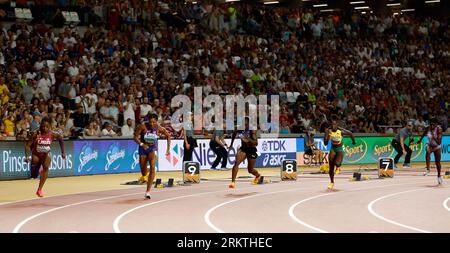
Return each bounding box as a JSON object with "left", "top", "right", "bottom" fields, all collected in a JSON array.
[{"left": 324, "top": 117, "right": 356, "bottom": 190}]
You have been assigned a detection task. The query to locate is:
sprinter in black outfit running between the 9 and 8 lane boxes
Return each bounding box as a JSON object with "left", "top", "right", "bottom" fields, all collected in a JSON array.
[{"left": 229, "top": 118, "right": 261, "bottom": 188}]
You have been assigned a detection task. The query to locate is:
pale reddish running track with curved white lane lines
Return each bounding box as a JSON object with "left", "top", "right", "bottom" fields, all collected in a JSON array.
[{"left": 0, "top": 172, "right": 450, "bottom": 233}]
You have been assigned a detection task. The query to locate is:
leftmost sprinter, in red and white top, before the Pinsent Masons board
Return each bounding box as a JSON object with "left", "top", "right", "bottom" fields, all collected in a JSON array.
[{"left": 25, "top": 118, "right": 66, "bottom": 198}]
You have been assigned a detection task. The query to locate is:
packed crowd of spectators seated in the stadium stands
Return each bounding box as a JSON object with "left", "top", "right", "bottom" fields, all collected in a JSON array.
[{"left": 0, "top": 0, "right": 450, "bottom": 139}]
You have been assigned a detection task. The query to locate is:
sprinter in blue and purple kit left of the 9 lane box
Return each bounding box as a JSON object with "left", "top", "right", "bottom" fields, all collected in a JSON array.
[{"left": 134, "top": 114, "right": 171, "bottom": 199}]
